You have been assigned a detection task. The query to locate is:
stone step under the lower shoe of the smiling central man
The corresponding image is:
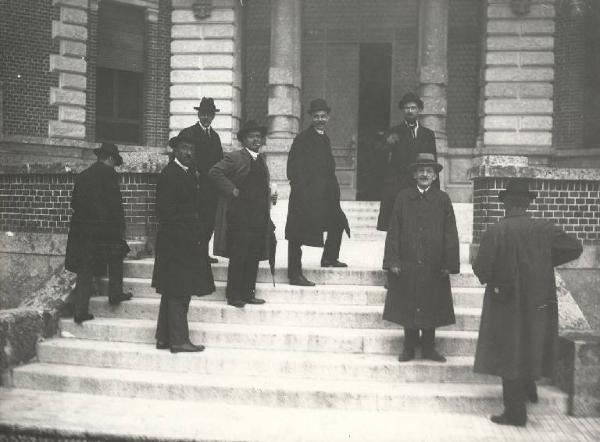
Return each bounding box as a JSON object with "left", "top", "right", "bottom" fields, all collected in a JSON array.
[{"left": 108, "top": 278, "right": 484, "bottom": 309}]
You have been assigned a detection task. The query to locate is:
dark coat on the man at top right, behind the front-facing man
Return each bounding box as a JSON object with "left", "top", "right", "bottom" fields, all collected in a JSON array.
[{"left": 377, "top": 122, "right": 439, "bottom": 231}]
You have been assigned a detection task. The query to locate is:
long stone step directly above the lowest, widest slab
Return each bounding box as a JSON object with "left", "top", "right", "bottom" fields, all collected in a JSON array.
[{"left": 13, "top": 362, "right": 567, "bottom": 414}]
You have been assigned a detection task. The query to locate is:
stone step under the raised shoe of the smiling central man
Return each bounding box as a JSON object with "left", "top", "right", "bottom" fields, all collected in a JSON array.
[{"left": 124, "top": 258, "right": 481, "bottom": 287}]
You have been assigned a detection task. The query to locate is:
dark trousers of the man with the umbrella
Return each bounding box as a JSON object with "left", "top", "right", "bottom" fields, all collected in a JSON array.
[{"left": 226, "top": 230, "right": 265, "bottom": 301}]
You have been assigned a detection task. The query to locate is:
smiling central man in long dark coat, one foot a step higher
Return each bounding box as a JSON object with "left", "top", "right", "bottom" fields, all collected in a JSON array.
[{"left": 285, "top": 99, "right": 350, "bottom": 286}]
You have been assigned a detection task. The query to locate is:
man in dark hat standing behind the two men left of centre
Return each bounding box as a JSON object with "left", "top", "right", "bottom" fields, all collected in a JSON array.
[{"left": 180, "top": 97, "right": 223, "bottom": 263}]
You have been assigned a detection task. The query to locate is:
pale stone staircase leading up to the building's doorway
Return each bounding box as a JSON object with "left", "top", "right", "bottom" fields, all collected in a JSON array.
[{"left": 1, "top": 202, "right": 567, "bottom": 440}]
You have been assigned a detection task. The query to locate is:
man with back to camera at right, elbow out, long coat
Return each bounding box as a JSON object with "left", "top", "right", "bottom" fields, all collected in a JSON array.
[{"left": 473, "top": 179, "right": 582, "bottom": 426}]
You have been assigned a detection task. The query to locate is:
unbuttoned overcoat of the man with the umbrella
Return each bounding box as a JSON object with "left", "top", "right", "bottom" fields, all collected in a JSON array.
[{"left": 209, "top": 148, "right": 275, "bottom": 261}]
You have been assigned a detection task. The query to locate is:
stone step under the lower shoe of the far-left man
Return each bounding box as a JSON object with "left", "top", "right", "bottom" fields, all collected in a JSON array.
[{"left": 60, "top": 318, "right": 477, "bottom": 356}]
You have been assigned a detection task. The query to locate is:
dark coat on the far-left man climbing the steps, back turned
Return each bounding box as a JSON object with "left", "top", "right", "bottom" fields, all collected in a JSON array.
[{"left": 65, "top": 161, "right": 129, "bottom": 273}]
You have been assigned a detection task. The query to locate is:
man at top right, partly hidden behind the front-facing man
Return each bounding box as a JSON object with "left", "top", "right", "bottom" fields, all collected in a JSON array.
[{"left": 377, "top": 92, "right": 440, "bottom": 231}]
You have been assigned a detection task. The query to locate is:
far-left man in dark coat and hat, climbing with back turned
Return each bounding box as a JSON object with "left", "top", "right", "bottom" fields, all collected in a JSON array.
[{"left": 65, "top": 143, "right": 132, "bottom": 324}]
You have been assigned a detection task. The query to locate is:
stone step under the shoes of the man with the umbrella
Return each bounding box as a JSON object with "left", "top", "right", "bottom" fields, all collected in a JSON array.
[{"left": 90, "top": 297, "right": 481, "bottom": 330}]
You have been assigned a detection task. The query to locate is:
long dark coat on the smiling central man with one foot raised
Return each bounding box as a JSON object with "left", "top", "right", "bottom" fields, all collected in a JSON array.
[{"left": 285, "top": 127, "right": 348, "bottom": 247}]
